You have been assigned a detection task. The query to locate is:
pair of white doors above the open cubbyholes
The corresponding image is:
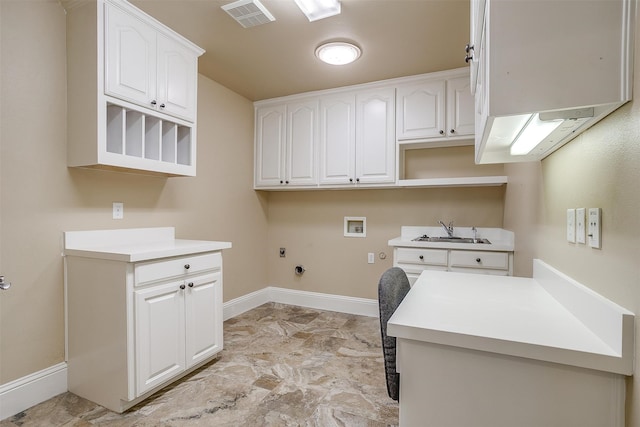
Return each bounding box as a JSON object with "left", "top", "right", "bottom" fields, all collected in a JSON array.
[{"left": 105, "top": 3, "right": 198, "bottom": 121}]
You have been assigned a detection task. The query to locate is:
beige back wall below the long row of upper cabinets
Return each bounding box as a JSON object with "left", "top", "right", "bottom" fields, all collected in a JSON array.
[{"left": 267, "top": 187, "right": 504, "bottom": 298}]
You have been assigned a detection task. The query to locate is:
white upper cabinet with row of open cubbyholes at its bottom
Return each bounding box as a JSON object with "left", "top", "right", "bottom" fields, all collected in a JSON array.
[{"left": 67, "top": 0, "right": 204, "bottom": 176}]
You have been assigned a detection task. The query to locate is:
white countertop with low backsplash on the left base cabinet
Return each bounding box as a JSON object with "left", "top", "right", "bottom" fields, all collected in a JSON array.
[{"left": 64, "top": 227, "right": 232, "bottom": 262}]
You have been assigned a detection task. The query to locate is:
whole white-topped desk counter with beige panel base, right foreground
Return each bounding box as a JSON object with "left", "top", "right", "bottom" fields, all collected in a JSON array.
[{"left": 388, "top": 260, "right": 634, "bottom": 427}]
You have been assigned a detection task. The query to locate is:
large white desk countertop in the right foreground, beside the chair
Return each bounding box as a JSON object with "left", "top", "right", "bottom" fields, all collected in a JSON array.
[{"left": 388, "top": 260, "right": 634, "bottom": 375}]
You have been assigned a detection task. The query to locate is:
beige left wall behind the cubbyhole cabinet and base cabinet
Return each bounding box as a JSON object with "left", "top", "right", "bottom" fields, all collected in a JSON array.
[{"left": 0, "top": 0, "right": 267, "bottom": 384}]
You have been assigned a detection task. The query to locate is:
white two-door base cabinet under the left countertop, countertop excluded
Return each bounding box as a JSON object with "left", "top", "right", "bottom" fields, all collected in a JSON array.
[{"left": 65, "top": 231, "right": 230, "bottom": 412}]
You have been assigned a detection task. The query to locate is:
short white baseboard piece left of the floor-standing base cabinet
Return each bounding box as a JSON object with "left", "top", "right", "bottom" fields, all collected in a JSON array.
[{"left": 0, "top": 362, "right": 67, "bottom": 420}]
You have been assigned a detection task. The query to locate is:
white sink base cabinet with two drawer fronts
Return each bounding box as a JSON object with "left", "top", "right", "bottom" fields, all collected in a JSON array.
[{"left": 393, "top": 247, "right": 513, "bottom": 285}]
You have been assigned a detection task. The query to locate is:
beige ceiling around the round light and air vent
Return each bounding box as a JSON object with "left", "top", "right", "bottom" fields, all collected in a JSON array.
[{"left": 131, "top": 0, "right": 470, "bottom": 101}]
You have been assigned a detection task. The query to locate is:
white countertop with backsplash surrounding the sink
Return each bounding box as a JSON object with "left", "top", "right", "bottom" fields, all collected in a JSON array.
[{"left": 388, "top": 226, "right": 515, "bottom": 252}]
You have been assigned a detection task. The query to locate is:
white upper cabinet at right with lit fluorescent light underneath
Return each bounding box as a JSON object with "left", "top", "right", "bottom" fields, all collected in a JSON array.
[{"left": 471, "top": 0, "right": 636, "bottom": 163}]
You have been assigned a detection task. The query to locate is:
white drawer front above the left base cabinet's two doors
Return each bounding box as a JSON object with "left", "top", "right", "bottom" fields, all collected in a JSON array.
[{"left": 134, "top": 252, "right": 222, "bottom": 286}]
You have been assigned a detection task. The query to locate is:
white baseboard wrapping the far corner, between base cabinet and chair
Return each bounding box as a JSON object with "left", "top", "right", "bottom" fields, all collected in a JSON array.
[{"left": 223, "top": 286, "right": 379, "bottom": 320}]
